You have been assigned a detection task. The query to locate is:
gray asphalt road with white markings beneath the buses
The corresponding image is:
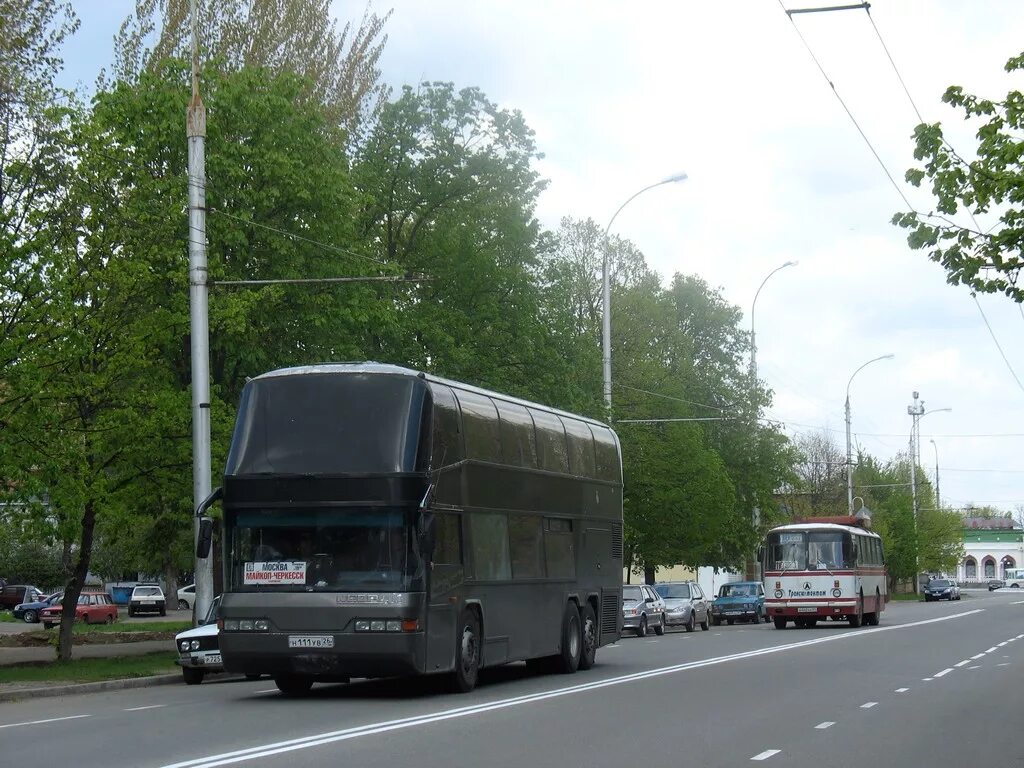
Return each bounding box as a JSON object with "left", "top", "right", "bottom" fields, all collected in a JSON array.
[{"left": 0, "top": 593, "right": 1024, "bottom": 768}]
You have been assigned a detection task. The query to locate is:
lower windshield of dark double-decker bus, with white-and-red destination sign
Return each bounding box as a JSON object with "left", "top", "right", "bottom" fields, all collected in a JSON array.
[{"left": 228, "top": 508, "right": 418, "bottom": 592}]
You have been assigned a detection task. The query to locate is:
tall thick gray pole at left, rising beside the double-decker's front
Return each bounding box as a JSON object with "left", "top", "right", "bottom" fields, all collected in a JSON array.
[{"left": 185, "top": 0, "right": 213, "bottom": 620}]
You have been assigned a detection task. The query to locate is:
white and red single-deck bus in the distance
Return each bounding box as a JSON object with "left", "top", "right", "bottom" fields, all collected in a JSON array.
[{"left": 760, "top": 516, "right": 889, "bottom": 630}]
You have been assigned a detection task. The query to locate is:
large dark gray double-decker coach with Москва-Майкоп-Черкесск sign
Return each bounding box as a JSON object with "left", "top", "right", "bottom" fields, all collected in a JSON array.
[{"left": 208, "top": 364, "right": 623, "bottom": 694}]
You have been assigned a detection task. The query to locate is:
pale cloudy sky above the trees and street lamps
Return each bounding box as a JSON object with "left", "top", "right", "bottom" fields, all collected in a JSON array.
[{"left": 65, "top": 0, "right": 1024, "bottom": 518}]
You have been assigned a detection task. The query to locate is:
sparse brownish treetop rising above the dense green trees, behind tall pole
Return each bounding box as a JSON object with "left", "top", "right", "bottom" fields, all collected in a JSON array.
[{"left": 115, "top": 0, "right": 391, "bottom": 139}]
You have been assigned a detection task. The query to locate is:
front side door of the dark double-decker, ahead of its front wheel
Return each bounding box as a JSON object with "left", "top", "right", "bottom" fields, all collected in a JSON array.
[{"left": 426, "top": 512, "right": 465, "bottom": 672}]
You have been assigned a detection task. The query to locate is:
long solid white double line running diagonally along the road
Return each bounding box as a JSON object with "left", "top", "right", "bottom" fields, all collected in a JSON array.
[{"left": 163, "top": 608, "right": 984, "bottom": 768}]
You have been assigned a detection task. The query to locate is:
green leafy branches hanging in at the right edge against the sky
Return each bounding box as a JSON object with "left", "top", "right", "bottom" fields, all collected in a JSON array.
[{"left": 893, "top": 54, "right": 1024, "bottom": 302}]
